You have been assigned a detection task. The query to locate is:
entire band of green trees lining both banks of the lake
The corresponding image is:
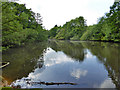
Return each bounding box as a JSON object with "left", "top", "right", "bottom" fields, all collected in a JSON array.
[{"left": 0, "top": 2, "right": 120, "bottom": 50}]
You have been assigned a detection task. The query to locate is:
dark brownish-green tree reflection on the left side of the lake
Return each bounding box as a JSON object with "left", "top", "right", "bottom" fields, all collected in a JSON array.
[{"left": 2, "top": 43, "right": 47, "bottom": 84}]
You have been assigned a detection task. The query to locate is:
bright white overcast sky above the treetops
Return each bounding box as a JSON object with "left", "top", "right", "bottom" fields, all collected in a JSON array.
[{"left": 16, "top": 0, "right": 114, "bottom": 29}]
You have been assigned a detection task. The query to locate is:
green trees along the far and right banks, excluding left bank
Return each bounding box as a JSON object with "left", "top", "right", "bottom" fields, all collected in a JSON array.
[{"left": 48, "top": 2, "right": 120, "bottom": 42}]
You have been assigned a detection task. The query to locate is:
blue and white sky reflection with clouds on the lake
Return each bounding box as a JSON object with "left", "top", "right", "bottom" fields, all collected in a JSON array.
[{"left": 11, "top": 47, "right": 115, "bottom": 88}]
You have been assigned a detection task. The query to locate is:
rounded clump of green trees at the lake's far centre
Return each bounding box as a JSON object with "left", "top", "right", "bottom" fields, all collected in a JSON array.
[{"left": 49, "top": 16, "right": 87, "bottom": 40}]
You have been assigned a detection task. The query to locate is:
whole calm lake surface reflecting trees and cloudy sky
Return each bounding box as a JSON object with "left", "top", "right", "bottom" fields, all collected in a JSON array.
[{"left": 2, "top": 41, "right": 120, "bottom": 88}]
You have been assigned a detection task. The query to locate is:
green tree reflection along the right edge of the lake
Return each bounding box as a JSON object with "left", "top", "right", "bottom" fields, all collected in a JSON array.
[{"left": 83, "top": 42, "right": 120, "bottom": 88}]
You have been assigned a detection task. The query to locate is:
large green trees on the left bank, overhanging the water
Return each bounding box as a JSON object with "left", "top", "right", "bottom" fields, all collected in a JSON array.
[{"left": 0, "top": 2, "right": 48, "bottom": 50}]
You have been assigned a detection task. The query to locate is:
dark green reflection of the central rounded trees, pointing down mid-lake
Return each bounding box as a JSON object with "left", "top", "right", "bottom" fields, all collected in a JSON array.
[{"left": 49, "top": 41, "right": 85, "bottom": 61}]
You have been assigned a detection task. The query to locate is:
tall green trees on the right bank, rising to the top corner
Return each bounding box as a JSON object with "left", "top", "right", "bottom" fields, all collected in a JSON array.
[{"left": 81, "top": 2, "right": 120, "bottom": 42}]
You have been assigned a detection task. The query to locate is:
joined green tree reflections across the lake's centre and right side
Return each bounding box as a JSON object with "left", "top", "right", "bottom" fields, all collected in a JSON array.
[{"left": 50, "top": 41, "right": 120, "bottom": 88}]
